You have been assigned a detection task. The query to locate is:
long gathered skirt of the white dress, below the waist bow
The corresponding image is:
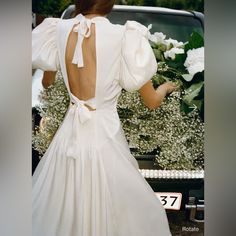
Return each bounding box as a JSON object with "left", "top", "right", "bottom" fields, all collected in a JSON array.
[{"left": 32, "top": 107, "right": 171, "bottom": 236}]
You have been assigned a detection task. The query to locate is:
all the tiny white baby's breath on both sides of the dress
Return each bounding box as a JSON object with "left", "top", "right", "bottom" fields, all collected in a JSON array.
[{"left": 33, "top": 71, "right": 204, "bottom": 170}]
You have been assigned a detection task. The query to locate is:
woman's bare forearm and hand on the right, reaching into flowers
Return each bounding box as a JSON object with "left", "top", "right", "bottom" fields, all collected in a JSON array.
[{"left": 139, "top": 81, "right": 177, "bottom": 110}]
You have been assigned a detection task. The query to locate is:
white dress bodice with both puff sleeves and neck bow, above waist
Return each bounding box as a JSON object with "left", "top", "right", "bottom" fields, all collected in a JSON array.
[{"left": 32, "top": 14, "right": 157, "bottom": 120}]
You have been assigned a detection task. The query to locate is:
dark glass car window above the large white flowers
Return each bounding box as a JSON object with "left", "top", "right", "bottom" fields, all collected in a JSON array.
[{"left": 108, "top": 11, "right": 203, "bottom": 42}]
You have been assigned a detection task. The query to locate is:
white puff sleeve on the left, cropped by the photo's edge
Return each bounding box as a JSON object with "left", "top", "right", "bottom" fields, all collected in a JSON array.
[{"left": 32, "top": 17, "right": 60, "bottom": 71}]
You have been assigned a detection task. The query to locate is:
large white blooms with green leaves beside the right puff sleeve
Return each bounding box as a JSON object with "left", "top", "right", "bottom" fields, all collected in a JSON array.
[{"left": 148, "top": 25, "right": 204, "bottom": 118}]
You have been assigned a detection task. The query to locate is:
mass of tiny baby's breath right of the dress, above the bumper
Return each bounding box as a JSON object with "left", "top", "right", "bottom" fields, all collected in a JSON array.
[{"left": 118, "top": 88, "right": 204, "bottom": 170}]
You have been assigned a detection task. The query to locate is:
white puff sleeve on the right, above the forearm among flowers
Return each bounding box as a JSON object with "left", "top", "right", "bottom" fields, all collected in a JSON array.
[{"left": 119, "top": 21, "right": 157, "bottom": 92}]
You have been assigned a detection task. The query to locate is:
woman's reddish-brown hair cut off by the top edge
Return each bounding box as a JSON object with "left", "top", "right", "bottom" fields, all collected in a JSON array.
[{"left": 75, "top": 0, "right": 116, "bottom": 15}]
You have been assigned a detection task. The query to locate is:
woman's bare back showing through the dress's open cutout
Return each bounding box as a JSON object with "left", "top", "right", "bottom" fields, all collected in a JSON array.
[{"left": 65, "top": 24, "right": 97, "bottom": 101}]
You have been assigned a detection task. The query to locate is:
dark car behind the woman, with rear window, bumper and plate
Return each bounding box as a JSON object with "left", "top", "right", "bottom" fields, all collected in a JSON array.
[{"left": 32, "top": 5, "right": 204, "bottom": 225}]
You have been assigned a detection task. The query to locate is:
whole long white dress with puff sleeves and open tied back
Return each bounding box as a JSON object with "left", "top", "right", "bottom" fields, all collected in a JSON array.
[{"left": 32, "top": 14, "right": 171, "bottom": 236}]
